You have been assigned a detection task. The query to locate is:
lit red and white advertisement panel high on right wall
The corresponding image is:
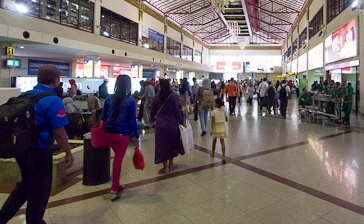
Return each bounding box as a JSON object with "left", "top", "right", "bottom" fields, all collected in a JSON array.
[{"left": 325, "top": 18, "right": 358, "bottom": 63}]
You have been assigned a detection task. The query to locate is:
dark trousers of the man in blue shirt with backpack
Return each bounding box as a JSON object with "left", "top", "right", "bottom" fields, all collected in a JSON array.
[{"left": 0, "top": 149, "right": 53, "bottom": 224}]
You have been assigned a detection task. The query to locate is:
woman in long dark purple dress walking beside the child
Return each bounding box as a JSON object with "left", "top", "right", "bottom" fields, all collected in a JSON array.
[{"left": 150, "top": 79, "right": 184, "bottom": 173}]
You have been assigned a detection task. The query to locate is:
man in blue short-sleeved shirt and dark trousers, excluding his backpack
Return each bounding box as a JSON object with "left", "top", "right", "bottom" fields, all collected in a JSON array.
[{"left": 0, "top": 65, "right": 74, "bottom": 224}]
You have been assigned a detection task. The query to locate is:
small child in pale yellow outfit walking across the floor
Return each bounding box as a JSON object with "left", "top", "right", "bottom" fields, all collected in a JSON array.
[{"left": 210, "top": 98, "right": 228, "bottom": 163}]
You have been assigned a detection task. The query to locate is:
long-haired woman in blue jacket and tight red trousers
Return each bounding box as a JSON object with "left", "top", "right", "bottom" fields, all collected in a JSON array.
[{"left": 101, "top": 75, "right": 139, "bottom": 201}]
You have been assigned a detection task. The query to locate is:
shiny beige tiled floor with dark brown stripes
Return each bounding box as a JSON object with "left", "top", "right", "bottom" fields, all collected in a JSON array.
[{"left": 0, "top": 99, "right": 364, "bottom": 224}]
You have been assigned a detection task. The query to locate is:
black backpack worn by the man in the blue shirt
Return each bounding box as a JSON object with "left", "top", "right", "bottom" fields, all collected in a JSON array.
[{"left": 0, "top": 92, "right": 53, "bottom": 158}]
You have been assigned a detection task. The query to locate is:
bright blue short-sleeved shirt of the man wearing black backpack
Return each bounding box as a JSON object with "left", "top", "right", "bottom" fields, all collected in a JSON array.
[{"left": 30, "top": 84, "right": 68, "bottom": 149}]
